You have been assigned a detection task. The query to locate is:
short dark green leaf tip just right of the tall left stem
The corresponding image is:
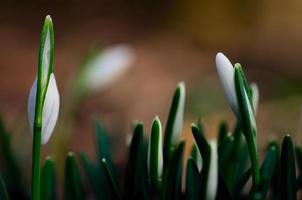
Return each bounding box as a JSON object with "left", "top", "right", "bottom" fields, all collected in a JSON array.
[{"left": 41, "top": 157, "right": 57, "bottom": 200}]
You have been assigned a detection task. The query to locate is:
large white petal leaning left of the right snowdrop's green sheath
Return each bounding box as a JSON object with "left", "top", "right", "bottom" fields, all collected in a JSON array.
[{"left": 216, "top": 53, "right": 238, "bottom": 115}]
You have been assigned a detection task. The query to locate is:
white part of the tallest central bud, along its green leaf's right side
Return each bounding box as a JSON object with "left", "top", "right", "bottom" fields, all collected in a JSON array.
[{"left": 172, "top": 82, "right": 186, "bottom": 145}]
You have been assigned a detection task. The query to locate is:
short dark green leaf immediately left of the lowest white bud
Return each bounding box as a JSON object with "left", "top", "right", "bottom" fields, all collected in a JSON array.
[{"left": 186, "top": 158, "right": 201, "bottom": 200}]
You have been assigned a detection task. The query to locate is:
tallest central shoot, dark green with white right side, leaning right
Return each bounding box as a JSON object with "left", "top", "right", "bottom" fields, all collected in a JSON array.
[{"left": 164, "top": 82, "right": 185, "bottom": 160}]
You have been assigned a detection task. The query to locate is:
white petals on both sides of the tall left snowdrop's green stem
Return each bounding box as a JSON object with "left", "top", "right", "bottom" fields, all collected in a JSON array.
[{"left": 28, "top": 73, "right": 60, "bottom": 144}]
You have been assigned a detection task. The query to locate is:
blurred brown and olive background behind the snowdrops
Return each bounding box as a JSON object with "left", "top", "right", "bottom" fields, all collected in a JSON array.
[{"left": 0, "top": 0, "right": 302, "bottom": 180}]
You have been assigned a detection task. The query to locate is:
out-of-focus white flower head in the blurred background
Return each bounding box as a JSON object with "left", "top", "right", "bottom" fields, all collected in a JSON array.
[{"left": 81, "top": 45, "right": 134, "bottom": 91}]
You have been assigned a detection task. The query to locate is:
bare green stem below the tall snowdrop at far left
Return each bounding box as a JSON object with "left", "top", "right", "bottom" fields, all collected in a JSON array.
[{"left": 32, "top": 125, "right": 42, "bottom": 200}]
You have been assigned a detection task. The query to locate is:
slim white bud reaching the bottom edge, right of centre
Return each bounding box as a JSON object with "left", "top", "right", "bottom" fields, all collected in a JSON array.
[{"left": 206, "top": 140, "right": 218, "bottom": 200}]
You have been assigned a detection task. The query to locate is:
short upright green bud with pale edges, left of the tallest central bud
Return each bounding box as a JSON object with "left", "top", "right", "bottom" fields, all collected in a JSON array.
[{"left": 147, "top": 117, "right": 163, "bottom": 186}]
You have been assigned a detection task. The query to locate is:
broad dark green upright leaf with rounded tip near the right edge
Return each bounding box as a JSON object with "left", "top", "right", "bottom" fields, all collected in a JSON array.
[{"left": 280, "top": 135, "right": 297, "bottom": 200}]
